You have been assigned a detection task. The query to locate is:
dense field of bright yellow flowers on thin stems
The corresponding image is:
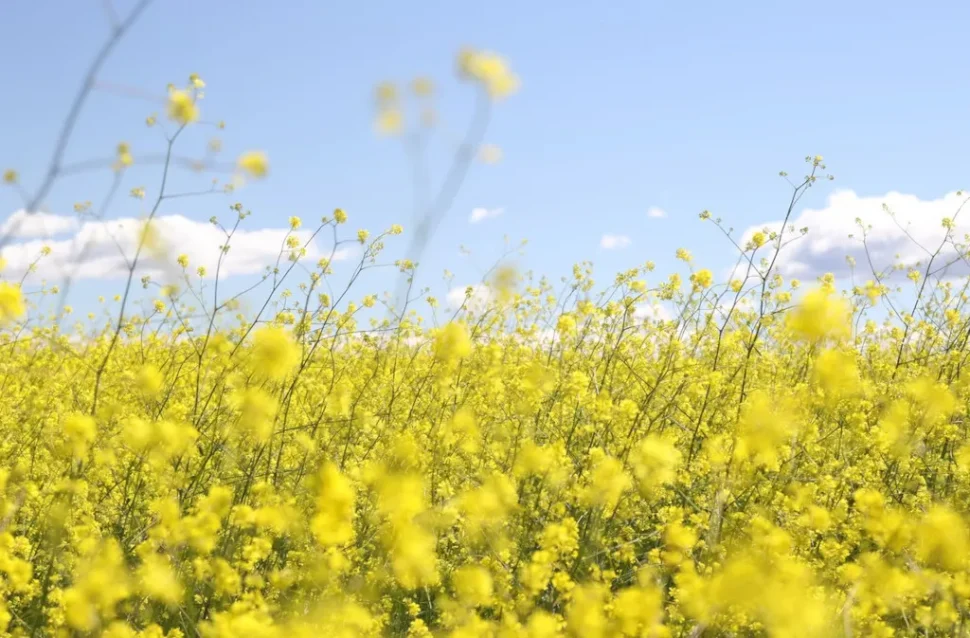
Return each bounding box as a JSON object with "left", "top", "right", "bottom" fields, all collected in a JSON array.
[{"left": 0, "top": 7, "right": 970, "bottom": 638}]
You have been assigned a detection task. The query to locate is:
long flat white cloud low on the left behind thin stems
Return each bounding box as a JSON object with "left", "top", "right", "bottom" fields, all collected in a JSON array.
[{"left": 0, "top": 214, "right": 355, "bottom": 280}]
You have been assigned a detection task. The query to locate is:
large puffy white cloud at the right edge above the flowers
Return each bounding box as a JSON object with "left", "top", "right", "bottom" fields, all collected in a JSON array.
[{"left": 739, "top": 190, "right": 970, "bottom": 279}]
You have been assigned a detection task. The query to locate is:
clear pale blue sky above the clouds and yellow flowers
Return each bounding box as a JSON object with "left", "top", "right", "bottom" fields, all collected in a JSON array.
[{"left": 0, "top": 0, "right": 970, "bottom": 320}]
